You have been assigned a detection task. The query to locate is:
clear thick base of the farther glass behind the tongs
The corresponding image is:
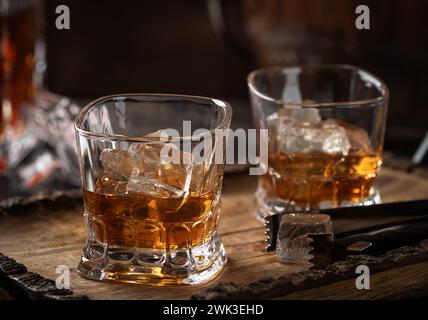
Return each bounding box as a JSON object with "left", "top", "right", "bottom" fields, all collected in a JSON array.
[{"left": 255, "top": 186, "right": 382, "bottom": 222}]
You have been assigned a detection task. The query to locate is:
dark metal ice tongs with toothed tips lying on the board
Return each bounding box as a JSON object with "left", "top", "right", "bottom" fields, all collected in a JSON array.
[{"left": 265, "top": 200, "right": 428, "bottom": 266}]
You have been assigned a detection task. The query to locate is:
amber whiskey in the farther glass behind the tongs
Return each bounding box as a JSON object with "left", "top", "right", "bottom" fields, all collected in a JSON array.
[{"left": 261, "top": 151, "right": 381, "bottom": 209}]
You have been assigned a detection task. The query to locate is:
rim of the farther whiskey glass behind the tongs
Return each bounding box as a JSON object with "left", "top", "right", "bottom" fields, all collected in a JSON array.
[{"left": 247, "top": 64, "right": 389, "bottom": 108}]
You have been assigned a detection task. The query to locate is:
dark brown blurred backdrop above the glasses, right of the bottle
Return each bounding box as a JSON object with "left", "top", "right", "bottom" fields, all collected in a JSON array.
[{"left": 45, "top": 0, "right": 428, "bottom": 156}]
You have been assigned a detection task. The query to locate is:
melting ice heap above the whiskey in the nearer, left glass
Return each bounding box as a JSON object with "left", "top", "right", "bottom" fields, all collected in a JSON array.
[{"left": 97, "top": 130, "right": 221, "bottom": 198}]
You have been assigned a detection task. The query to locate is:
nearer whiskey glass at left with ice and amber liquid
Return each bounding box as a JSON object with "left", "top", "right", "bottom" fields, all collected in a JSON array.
[{"left": 75, "top": 94, "right": 232, "bottom": 286}]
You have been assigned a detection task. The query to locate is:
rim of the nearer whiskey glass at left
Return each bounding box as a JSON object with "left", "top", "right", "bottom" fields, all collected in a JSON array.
[{"left": 74, "top": 93, "right": 232, "bottom": 143}]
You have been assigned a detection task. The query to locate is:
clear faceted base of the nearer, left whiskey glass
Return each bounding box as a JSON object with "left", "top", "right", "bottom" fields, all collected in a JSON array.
[{"left": 77, "top": 233, "right": 227, "bottom": 286}]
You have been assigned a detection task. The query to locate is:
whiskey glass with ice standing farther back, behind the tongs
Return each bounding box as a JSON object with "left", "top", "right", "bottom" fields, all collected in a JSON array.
[{"left": 248, "top": 65, "right": 388, "bottom": 218}]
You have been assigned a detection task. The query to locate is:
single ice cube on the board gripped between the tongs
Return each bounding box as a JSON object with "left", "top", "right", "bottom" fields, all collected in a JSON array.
[{"left": 276, "top": 213, "right": 332, "bottom": 263}]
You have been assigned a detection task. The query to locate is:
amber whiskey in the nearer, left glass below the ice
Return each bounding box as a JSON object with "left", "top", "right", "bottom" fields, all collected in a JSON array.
[{"left": 83, "top": 191, "right": 218, "bottom": 250}]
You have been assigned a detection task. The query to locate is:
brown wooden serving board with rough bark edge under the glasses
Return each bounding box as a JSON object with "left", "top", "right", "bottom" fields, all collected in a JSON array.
[{"left": 0, "top": 168, "right": 428, "bottom": 299}]
